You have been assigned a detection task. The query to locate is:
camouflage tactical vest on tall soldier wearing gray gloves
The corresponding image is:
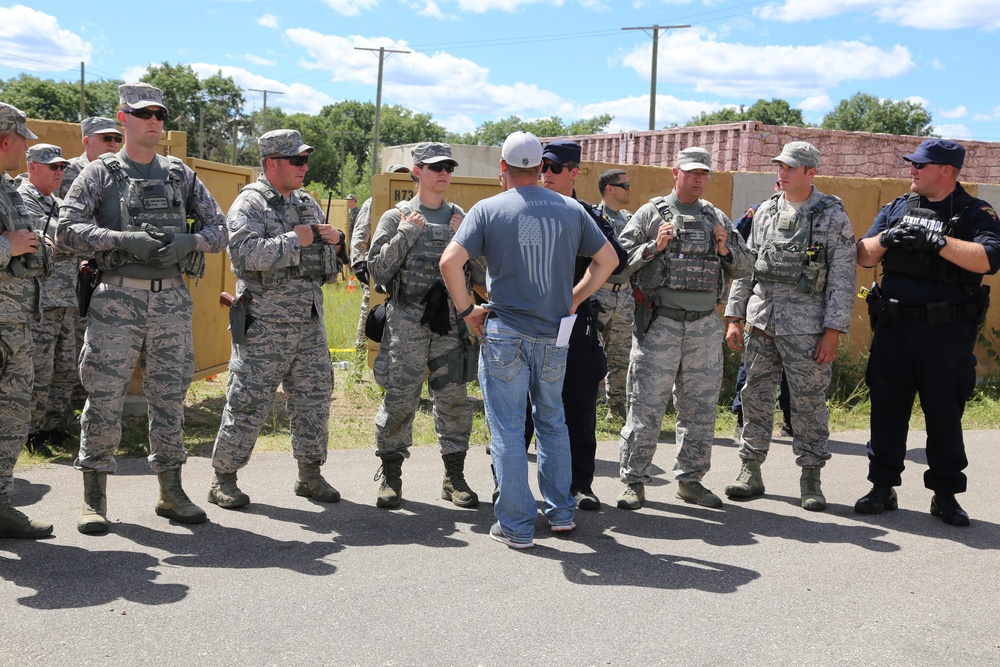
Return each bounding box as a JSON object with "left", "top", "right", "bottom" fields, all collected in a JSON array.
[{"left": 96, "top": 153, "right": 205, "bottom": 278}]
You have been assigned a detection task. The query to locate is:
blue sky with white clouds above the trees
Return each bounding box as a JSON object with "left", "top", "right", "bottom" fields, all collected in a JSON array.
[{"left": 0, "top": 0, "right": 1000, "bottom": 141}]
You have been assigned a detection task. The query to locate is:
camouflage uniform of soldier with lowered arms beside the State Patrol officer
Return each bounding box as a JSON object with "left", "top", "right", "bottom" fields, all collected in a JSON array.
[{"left": 726, "top": 187, "right": 857, "bottom": 468}]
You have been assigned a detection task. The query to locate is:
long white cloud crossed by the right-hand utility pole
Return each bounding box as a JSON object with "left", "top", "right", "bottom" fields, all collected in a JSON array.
[{"left": 621, "top": 28, "right": 914, "bottom": 97}]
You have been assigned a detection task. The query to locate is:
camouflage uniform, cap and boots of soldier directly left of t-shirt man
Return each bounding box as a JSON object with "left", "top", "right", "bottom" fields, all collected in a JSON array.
[{"left": 368, "top": 143, "right": 486, "bottom": 508}]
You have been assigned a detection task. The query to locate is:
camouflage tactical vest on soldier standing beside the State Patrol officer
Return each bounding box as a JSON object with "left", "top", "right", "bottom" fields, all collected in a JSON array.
[{"left": 753, "top": 192, "right": 843, "bottom": 295}]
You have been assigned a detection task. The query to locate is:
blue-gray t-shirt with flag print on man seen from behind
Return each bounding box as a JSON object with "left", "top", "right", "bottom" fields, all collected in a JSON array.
[{"left": 454, "top": 186, "right": 607, "bottom": 338}]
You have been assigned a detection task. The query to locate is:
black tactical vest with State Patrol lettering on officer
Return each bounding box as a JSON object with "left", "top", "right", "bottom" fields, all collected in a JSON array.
[{"left": 882, "top": 192, "right": 983, "bottom": 286}]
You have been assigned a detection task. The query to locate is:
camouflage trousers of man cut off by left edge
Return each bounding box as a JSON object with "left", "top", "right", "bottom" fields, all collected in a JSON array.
[{"left": 0, "top": 323, "right": 34, "bottom": 497}]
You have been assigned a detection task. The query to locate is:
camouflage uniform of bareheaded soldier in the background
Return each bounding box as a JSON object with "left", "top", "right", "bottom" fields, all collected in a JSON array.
[{"left": 594, "top": 201, "right": 635, "bottom": 413}]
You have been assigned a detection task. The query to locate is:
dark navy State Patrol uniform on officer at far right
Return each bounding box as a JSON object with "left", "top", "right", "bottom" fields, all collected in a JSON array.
[{"left": 865, "top": 184, "right": 1000, "bottom": 494}]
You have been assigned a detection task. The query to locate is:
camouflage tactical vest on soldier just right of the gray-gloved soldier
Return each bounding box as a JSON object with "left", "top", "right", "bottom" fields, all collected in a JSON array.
[{"left": 243, "top": 181, "right": 337, "bottom": 287}]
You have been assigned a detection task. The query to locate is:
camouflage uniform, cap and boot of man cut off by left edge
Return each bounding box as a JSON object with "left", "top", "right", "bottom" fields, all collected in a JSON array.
[{"left": 0, "top": 103, "right": 52, "bottom": 538}]
